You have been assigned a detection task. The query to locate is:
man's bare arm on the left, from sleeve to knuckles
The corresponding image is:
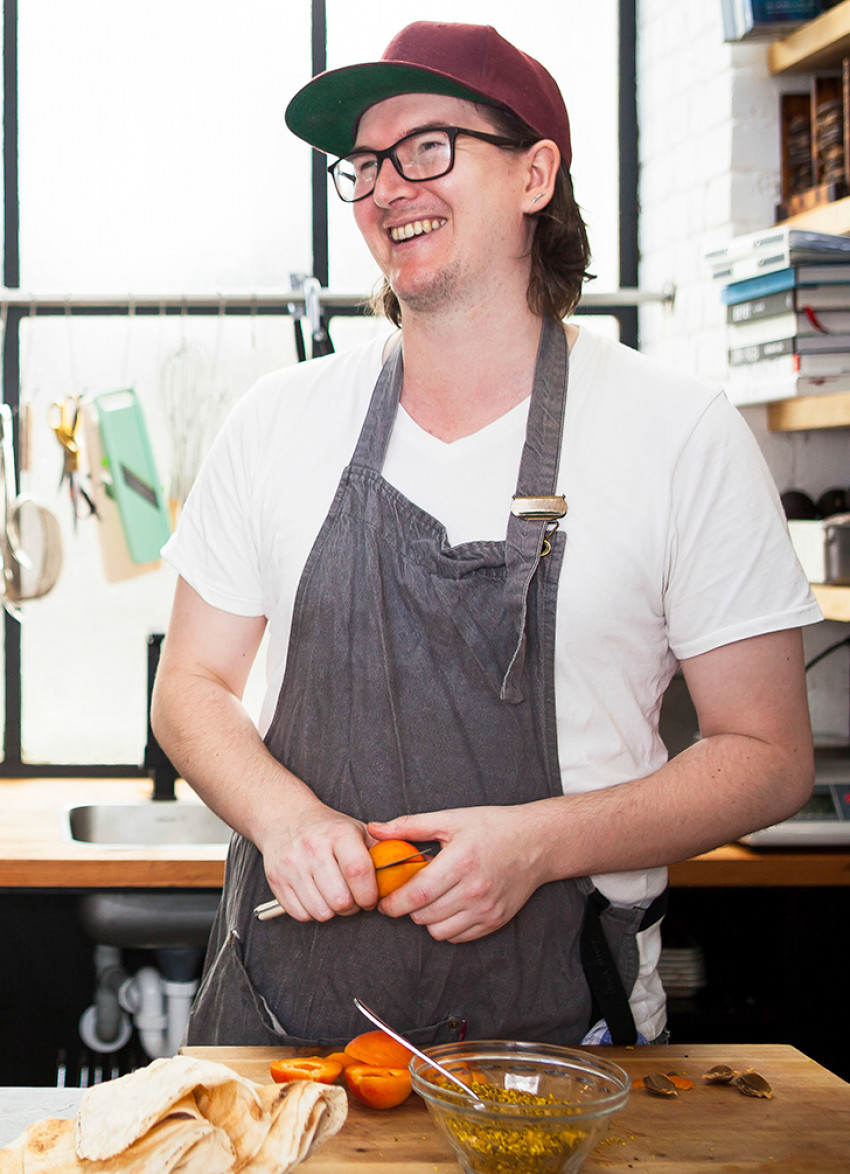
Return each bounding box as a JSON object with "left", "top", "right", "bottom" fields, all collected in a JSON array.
[{"left": 151, "top": 579, "right": 378, "bottom": 922}]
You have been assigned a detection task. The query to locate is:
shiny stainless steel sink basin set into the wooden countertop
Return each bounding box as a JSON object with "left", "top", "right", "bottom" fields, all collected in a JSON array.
[{"left": 66, "top": 799, "right": 230, "bottom": 848}]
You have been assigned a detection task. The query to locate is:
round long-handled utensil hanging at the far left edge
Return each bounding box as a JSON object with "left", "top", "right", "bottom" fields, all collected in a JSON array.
[{"left": 0, "top": 404, "right": 62, "bottom": 619}]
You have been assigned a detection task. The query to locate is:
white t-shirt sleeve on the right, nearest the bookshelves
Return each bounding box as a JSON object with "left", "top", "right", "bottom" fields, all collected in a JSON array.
[{"left": 665, "top": 394, "right": 822, "bottom": 660}]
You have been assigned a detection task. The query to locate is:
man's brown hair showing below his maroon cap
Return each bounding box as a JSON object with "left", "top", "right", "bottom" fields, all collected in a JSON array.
[{"left": 371, "top": 103, "right": 593, "bottom": 326}]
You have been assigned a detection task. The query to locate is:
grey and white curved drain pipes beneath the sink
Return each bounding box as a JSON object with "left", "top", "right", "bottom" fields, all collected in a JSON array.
[{"left": 79, "top": 945, "right": 198, "bottom": 1060}]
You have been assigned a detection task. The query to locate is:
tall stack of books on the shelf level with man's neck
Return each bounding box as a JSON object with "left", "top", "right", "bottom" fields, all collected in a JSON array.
[{"left": 704, "top": 225, "right": 850, "bottom": 405}]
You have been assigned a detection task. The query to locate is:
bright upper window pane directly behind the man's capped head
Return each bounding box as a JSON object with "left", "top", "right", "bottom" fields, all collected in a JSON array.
[{"left": 328, "top": 0, "right": 620, "bottom": 292}]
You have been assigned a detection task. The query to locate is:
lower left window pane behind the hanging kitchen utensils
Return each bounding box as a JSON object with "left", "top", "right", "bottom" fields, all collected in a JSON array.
[{"left": 21, "top": 315, "right": 296, "bottom": 763}]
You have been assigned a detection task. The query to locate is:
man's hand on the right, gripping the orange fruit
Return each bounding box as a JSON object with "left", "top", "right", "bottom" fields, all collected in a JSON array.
[{"left": 367, "top": 803, "right": 551, "bottom": 942}]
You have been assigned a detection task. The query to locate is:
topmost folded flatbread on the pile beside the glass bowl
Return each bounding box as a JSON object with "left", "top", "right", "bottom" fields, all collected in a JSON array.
[{"left": 76, "top": 1055, "right": 259, "bottom": 1161}]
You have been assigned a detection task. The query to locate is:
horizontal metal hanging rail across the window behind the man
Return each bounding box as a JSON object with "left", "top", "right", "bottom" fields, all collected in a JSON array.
[{"left": 0, "top": 286, "right": 673, "bottom": 315}]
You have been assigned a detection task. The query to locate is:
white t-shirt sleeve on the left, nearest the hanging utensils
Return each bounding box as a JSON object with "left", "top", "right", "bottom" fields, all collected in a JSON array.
[{"left": 162, "top": 392, "right": 264, "bottom": 616}]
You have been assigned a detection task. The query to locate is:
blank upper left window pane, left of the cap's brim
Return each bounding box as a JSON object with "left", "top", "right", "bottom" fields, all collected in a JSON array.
[{"left": 19, "top": 0, "right": 311, "bottom": 292}]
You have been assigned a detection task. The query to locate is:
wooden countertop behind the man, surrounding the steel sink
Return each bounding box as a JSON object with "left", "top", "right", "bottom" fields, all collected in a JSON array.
[{"left": 0, "top": 778, "right": 850, "bottom": 889}]
